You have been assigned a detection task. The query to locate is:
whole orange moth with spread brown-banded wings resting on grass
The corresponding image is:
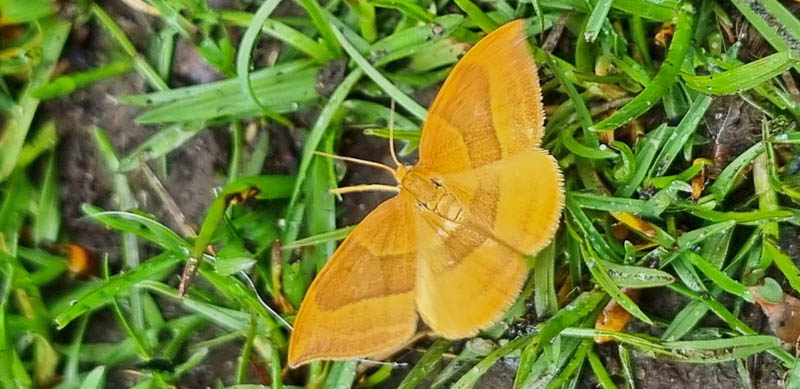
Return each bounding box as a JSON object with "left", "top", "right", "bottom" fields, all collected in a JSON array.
[{"left": 289, "top": 21, "right": 564, "bottom": 367}]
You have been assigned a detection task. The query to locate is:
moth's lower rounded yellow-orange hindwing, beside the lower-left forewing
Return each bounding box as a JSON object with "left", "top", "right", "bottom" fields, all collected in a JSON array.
[{"left": 416, "top": 213, "right": 527, "bottom": 339}]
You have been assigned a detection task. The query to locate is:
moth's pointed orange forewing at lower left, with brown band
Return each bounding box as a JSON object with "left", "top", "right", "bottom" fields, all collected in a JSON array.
[{"left": 289, "top": 193, "right": 417, "bottom": 367}]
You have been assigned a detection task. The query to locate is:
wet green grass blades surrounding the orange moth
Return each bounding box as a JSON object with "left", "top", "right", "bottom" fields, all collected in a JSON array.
[{"left": 0, "top": 0, "right": 800, "bottom": 389}]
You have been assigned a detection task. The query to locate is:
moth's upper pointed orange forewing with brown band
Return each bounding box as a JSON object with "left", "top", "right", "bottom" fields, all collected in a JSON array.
[{"left": 418, "top": 20, "right": 544, "bottom": 173}]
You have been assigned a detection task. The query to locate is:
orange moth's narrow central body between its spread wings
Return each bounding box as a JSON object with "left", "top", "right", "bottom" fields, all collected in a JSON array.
[{"left": 400, "top": 169, "right": 463, "bottom": 222}]
